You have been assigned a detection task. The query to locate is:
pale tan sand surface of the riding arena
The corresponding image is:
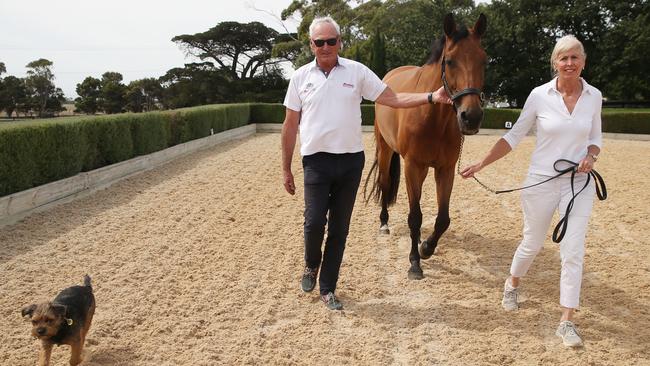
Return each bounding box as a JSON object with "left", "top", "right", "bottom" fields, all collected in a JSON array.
[{"left": 0, "top": 133, "right": 650, "bottom": 365}]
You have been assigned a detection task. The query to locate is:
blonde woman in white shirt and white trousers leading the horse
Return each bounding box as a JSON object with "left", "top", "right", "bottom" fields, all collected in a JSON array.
[{"left": 461, "top": 36, "right": 602, "bottom": 347}]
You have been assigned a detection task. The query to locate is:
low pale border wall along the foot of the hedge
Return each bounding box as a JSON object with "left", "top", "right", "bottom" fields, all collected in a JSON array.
[{"left": 0, "top": 123, "right": 650, "bottom": 228}]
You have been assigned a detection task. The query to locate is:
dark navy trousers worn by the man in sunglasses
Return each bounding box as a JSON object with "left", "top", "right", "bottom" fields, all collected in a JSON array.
[{"left": 302, "top": 151, "right": 365, "bottom": 295}]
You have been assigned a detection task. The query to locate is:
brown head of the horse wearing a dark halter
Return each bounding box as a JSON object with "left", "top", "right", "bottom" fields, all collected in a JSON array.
[{"left": 441, "top": 13, "right": 487, "bottom": 135}]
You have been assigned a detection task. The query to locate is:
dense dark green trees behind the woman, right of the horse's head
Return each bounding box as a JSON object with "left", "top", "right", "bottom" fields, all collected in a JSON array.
[{"left": 479, "top": 0, "right": 650, "bottom": 107}]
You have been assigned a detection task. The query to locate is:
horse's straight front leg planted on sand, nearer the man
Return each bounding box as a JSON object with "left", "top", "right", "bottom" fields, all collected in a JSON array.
[{"left": 404, "top": 161, "right": 428, "bottom": 280}]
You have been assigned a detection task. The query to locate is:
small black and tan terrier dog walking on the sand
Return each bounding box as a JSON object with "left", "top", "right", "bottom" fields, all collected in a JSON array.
[{"left": 22, "top": 275, "right": 95, "bottom": 366}]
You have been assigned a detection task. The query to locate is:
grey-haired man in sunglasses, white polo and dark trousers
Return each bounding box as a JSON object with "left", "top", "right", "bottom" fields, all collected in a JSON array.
[{"left": 282, "top": 17, "right": 451, "bottom": 310}]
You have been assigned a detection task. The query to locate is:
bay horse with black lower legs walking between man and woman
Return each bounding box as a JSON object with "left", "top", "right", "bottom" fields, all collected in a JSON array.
[{"left": 364, "top": 13, "right": 487, "bottom": 280}]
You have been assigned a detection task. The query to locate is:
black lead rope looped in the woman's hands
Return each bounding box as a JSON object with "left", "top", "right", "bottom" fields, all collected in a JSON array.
[{"left": 457, "top": 134, "right": 607, "bottom": 243}]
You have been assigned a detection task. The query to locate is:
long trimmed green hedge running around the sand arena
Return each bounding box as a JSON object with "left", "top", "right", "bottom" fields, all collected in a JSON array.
[{"left": 0, "top": 103, "right": 650, "bottom": 197}]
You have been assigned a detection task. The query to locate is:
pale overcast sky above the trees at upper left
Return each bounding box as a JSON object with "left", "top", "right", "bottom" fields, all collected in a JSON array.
[{"left": 0, "top": 0, "right": 298, "bottom": 98}]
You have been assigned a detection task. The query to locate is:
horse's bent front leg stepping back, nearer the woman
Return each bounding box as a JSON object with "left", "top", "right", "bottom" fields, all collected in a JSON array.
[{"left": 420, "top": 167, "right": 454, "bottom": 259}]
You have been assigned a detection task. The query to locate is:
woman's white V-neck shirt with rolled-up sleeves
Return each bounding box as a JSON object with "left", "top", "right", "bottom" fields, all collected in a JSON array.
[{"left": 503, "top": 78, "right": 603, "bottom": 175}]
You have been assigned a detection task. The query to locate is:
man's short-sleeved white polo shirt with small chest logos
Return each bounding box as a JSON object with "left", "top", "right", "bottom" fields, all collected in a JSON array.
[{"left": 284, "top": 57, "right": 386, "bottom": 156}]
